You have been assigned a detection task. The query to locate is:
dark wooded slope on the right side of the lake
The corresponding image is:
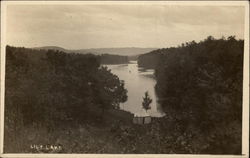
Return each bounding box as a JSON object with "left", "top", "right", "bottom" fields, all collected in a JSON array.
[{"left": 138, "top": 36, "right": 244, "bottom": 154}]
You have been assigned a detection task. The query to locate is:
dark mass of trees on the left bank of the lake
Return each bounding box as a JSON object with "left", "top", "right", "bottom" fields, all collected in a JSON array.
[{"left": 5, "top": 46, "right": 127, "bottom": 150}]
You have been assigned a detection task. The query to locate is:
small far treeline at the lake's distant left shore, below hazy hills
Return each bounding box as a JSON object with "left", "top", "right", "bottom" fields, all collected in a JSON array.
[{"left": 100, "top": 54, "right": 128, "bottom": 64}]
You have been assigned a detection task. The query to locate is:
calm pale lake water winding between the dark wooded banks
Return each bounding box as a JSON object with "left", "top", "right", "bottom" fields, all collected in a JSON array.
[{"left": 105, "top": 61, "right": 164, "bottom": 117}]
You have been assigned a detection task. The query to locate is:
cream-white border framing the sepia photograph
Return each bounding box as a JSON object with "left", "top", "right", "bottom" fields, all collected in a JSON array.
[{"left": 0, "top": 1, "right": 249, "bottom": 158}]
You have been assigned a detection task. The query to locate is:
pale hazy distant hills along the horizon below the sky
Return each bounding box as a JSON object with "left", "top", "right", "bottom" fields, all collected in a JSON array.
[{"left": 33, "top": 46, "right": 158, "bottom": 56}]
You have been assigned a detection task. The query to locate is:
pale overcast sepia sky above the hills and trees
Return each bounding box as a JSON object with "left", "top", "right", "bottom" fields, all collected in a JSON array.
[{"left": 6, "top": 5, "right": 244, "bottom": 49}]
